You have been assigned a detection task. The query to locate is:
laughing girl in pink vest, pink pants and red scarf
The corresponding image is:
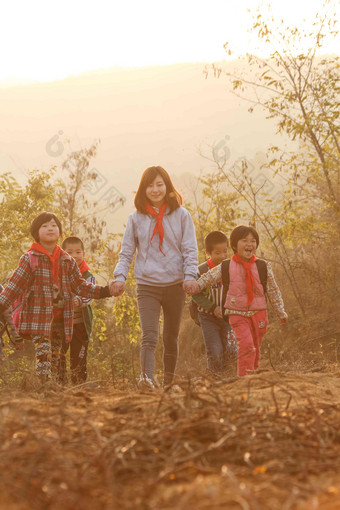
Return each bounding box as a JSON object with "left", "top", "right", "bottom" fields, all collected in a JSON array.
[{"left": 187, "top": 225, "right": 288, "bottom": 376}]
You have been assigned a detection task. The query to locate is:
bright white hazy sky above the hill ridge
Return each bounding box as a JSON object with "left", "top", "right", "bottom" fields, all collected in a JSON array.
[{"left": 0, "top": 0, "right": 338, "bottom": 81}]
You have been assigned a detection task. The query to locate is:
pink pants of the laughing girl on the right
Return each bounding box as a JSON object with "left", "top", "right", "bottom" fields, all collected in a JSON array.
[{"left": 229, "top": 310, "right": 268, "bottom": 376}]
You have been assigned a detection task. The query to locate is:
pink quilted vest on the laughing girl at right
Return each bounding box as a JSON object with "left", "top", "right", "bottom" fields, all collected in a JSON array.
[{"left": 224, "top": 260, "right": 267, "bottom": 311}]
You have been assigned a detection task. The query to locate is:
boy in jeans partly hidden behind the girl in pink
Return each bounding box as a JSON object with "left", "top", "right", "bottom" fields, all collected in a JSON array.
[{"left": 190, "top": 230, "right": 237, "bottom": 373}]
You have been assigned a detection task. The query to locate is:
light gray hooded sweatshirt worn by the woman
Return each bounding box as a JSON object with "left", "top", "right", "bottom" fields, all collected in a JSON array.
[{"left": 114, "top": 207, "right": 198, "bottom": 287}]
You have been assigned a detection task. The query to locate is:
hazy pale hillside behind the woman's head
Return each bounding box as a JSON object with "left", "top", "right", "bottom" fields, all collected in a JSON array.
[{"left": 0, "top": 63, "right": 277, "bottom": 229}]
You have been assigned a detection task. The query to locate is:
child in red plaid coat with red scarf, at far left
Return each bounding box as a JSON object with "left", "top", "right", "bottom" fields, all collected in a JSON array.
[{"left": 0, "top": 212, "right": 111, "bottom": 380}]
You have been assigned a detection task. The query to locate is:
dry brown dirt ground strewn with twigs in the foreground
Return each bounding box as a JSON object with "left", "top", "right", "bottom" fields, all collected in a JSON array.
[{"left": 0, "top": 370, "right": 340, "bottom": 510}]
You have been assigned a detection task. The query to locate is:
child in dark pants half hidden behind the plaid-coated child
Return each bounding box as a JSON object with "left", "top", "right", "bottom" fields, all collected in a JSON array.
[{"left": 60, "top": 236, "right": 96, "bottom": 384}]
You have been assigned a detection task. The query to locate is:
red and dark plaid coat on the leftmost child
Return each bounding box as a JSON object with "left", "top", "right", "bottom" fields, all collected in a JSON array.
[{"left": 0, "top": 250, "right": 107, "bottom": 342}]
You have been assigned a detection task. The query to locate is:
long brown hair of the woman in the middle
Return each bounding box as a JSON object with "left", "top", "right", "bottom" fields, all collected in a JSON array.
[{"left": 135, "top": 166, "right": 182, "bottom": 214}]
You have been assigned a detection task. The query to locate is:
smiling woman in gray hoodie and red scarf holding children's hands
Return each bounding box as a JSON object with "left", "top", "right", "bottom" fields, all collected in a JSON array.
[{"left": 111, "top": 166, "right": 197, "bottom": 388}]
